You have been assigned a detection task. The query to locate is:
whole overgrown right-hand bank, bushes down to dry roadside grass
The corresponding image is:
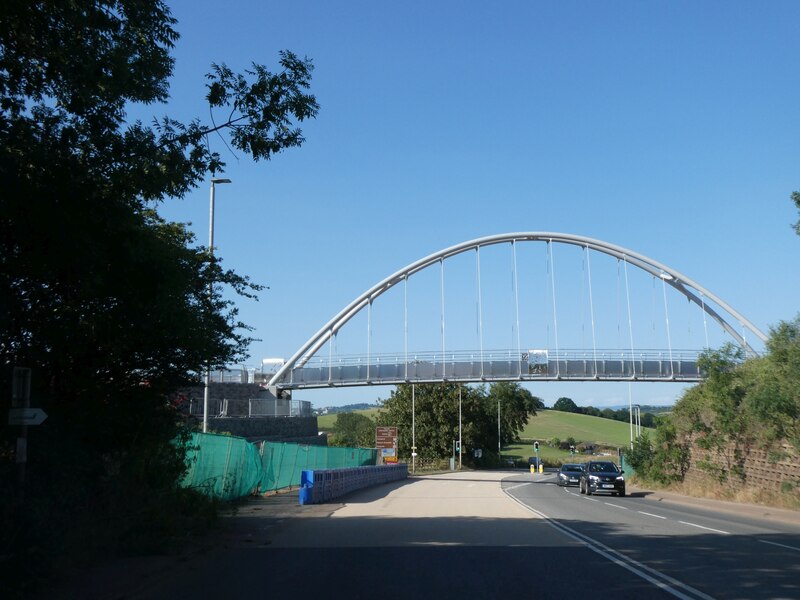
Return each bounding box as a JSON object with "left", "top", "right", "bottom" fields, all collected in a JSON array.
[{"left": 628, "top": 316, "right": 800, "bottom": 508}]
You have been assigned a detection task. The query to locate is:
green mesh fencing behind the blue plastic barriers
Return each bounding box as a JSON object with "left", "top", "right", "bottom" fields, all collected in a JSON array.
[{"left": 182, "top": 433, "right": 377, "bottom": 500}]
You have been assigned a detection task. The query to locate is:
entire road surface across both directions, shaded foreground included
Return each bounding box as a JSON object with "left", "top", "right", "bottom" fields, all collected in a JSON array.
[{"left": 44, "top": 471, "right": 800, "bottom": 600}]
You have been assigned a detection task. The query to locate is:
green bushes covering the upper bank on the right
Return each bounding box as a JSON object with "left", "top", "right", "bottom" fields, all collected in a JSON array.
[{"left": 628, "top": 316, "right": 800, "bottom": 482}]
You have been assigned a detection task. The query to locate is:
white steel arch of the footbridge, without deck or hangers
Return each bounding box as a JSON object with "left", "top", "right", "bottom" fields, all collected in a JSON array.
[{"left": 269, "top": 232, "right": 767, "bottom": 385}]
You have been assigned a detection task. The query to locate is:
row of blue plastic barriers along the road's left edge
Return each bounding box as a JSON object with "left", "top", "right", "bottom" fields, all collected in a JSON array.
[{"left": 300, "top": 464, "right": 408, "bottom": 504}]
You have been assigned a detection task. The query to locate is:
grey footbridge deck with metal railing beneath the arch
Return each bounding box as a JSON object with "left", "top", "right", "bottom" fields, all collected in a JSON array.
[{"left": 280, "top": 350, "right": 701, "bottom": 387}]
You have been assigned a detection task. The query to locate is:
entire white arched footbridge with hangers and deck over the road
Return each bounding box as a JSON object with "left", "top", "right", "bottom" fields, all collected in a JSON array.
[{"left": 269, "top": 232, "right": 767, "bottom": 389}]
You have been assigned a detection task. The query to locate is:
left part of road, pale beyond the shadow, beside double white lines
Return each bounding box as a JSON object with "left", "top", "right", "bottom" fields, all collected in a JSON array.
[{"left": 133, "top": 472, "right": 684, "bottom": 600}]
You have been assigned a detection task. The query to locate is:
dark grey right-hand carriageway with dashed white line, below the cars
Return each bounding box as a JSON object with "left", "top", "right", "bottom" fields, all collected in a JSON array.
[{"left": 503, "top": 475, "right": 800, "bottom": 599}]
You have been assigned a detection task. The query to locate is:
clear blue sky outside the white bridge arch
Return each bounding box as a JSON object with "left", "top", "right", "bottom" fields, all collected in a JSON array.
[{"left": 152, "top": 0, "right": 800, "bottom": 406}]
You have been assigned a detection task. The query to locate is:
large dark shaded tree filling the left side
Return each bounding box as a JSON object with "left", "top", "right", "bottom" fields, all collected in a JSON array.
[{"left": 0, "top": 0, "right": 318, "bottom": 580}]
